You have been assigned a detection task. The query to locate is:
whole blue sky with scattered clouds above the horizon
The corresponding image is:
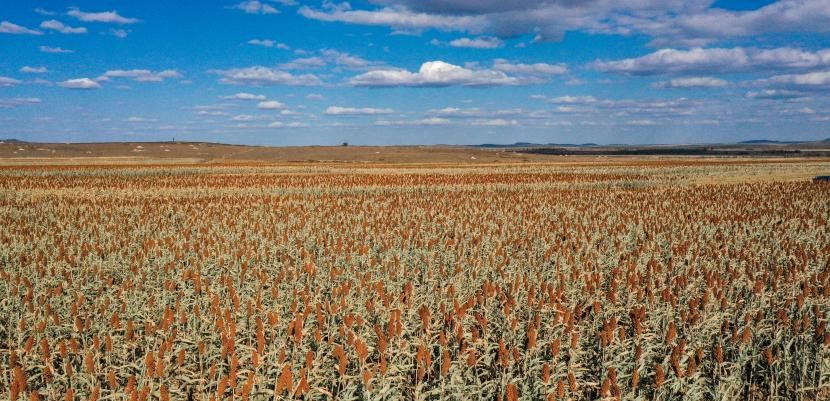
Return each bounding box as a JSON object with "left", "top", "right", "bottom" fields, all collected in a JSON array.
[{"left": 0, "top": 0, "right": 830, "bottom": 145}]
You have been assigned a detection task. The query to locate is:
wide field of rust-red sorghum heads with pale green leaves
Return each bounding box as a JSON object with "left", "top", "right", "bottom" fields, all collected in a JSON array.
[{"left": 0, "top": 159, "right": 830, "bottom": 401}]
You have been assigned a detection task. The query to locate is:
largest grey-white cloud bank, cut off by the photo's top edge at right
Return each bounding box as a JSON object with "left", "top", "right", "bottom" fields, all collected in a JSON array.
[{"left": 299, "top": 0, "right": 830, "bottom": 45}]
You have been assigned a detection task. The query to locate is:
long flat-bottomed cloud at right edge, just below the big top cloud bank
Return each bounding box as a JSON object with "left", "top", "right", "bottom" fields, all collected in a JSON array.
[{"left": 593, "top": 47, "right": 830, "bottom": 75}]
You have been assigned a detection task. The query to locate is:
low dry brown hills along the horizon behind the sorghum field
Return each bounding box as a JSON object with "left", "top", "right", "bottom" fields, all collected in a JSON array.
[{"left": 0, "top": 141, "right": 830, "bottom": 165}]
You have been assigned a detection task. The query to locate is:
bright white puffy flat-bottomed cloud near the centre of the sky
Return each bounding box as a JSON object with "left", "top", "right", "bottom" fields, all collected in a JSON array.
[{"left": 349, "top": 61, "right": 522, "bottom": 87}]
